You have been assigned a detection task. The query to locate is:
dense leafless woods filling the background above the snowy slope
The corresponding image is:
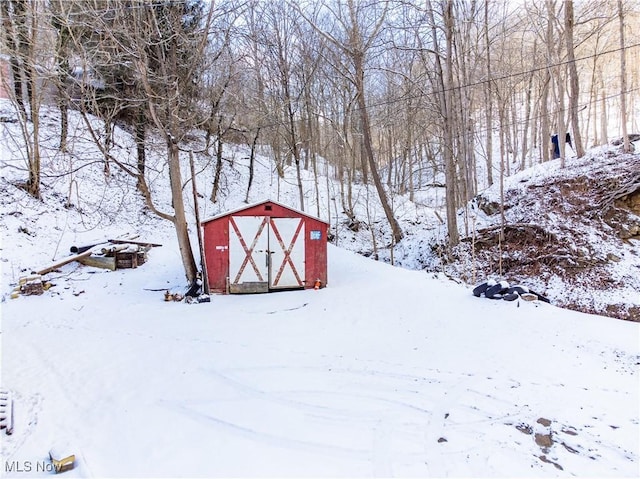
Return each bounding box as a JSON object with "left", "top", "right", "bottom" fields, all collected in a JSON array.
[{"left": 0, "top": 0, "right": 640, "bottom": 292}]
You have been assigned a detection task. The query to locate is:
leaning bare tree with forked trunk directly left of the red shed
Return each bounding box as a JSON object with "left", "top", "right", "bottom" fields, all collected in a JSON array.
[{"left": 65, "top": 0, "right": 214, "bottom": 284}]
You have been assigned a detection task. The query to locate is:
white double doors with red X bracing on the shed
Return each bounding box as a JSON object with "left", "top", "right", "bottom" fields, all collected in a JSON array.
[{"left": 229, "top": 216, "right": 305, "bottom": 293}]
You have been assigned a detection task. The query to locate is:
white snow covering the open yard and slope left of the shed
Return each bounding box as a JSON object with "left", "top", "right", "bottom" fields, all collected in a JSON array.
[{"left": 0, "top": 98, "right": 640, "bottom": 477}]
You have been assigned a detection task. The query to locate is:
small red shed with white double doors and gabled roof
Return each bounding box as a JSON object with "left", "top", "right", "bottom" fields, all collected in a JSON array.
[{"left": 202, "top": 200, "right": 329, "bottom": 293}]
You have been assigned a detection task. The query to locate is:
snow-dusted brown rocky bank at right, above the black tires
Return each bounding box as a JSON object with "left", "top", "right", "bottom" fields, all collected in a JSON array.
[{"left": 450, "top": 148, "right": 640, "bottom": 321}]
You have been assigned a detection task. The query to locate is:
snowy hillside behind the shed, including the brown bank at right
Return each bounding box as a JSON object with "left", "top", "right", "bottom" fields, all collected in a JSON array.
[{"left": 0, "top": 101, "right": 640, "bottom": 321}]
